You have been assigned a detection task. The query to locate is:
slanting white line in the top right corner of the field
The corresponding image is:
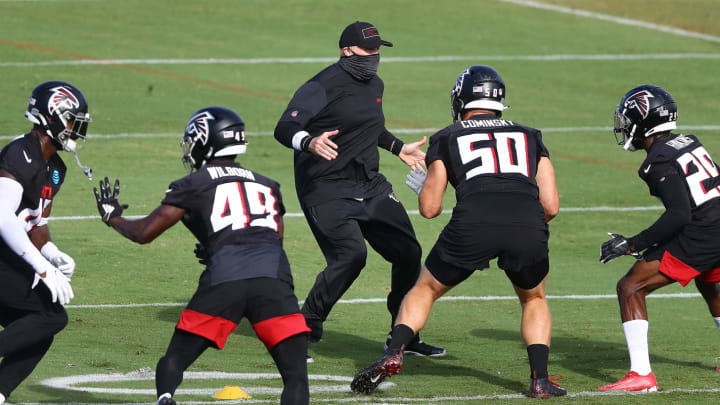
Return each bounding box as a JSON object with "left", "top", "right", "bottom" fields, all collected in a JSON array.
[{"left": 500, "top": 0, "right": 720, "bottom": 42}]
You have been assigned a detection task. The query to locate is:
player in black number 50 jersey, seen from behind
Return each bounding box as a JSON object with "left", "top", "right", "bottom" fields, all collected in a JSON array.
[{"left": 351, "top": 65, "right": 567, "bottom": 398}]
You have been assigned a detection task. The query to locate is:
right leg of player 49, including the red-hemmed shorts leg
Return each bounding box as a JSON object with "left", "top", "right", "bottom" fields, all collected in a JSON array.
[{"left": 247, "top": 278, "right": 310, "bottom": 405}]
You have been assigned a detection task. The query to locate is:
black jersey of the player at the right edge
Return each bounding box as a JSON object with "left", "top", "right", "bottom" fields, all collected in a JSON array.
[{"left": 638, "top": 134, "right": 720, "bottom": 225}]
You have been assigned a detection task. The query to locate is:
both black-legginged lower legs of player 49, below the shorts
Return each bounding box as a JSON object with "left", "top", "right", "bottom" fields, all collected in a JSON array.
[{"left": 155, "top": 329, "right": 310, "bottom": 405}]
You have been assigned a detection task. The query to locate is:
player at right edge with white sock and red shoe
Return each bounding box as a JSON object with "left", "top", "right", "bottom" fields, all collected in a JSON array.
[{"left": 600, "top": 85, "right": 720, "bottom": 392}]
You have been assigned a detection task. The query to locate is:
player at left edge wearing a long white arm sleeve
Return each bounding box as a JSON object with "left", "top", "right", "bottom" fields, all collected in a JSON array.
[{"left": 0, "top": 81, "right": 91, "bottom": 404}]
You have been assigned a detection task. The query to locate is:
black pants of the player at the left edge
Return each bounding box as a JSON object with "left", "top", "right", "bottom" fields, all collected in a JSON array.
[{"left": 0, "top": 269, "right": 68, "bottom": 398}]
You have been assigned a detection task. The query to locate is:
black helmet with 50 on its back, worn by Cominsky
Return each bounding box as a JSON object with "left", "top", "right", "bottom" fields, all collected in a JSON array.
[{"left": 450, "top": 65, "right": 509, "bottom": 121}]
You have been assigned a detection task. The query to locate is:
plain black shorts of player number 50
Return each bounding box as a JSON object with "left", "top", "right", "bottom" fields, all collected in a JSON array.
[{"left": 425, "top": 193, "right": 549, "bottom": 289}]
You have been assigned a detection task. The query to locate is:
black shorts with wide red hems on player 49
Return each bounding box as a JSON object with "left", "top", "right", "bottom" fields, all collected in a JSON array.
[{"left": 177, "top": 271, "right": 310, "bottom": 350}]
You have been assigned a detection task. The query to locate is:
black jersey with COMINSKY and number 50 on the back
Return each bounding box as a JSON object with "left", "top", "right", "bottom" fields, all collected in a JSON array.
[{"left": 425, "top": 115, "right": 549, "bottom": 201}]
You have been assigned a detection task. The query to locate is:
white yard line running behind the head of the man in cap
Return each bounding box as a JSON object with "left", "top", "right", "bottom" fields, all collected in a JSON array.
[{"left": 0, "top": 52, "right": 720, "bottom": 67}]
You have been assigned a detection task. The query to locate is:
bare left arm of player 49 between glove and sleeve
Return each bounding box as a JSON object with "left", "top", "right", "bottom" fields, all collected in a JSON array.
[{"left": 108, "top": 204, "right": 185, "bottom": 244}]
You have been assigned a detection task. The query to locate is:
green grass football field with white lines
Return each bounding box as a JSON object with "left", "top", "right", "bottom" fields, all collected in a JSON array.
[{"left": 0, "top": 0, "right": 720, "bottom": 404}]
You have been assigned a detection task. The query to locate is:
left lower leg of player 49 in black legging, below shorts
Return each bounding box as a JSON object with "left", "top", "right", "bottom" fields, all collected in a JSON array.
[{"left": 155, "top": 329, "right": 212, "bottom": 403}]
